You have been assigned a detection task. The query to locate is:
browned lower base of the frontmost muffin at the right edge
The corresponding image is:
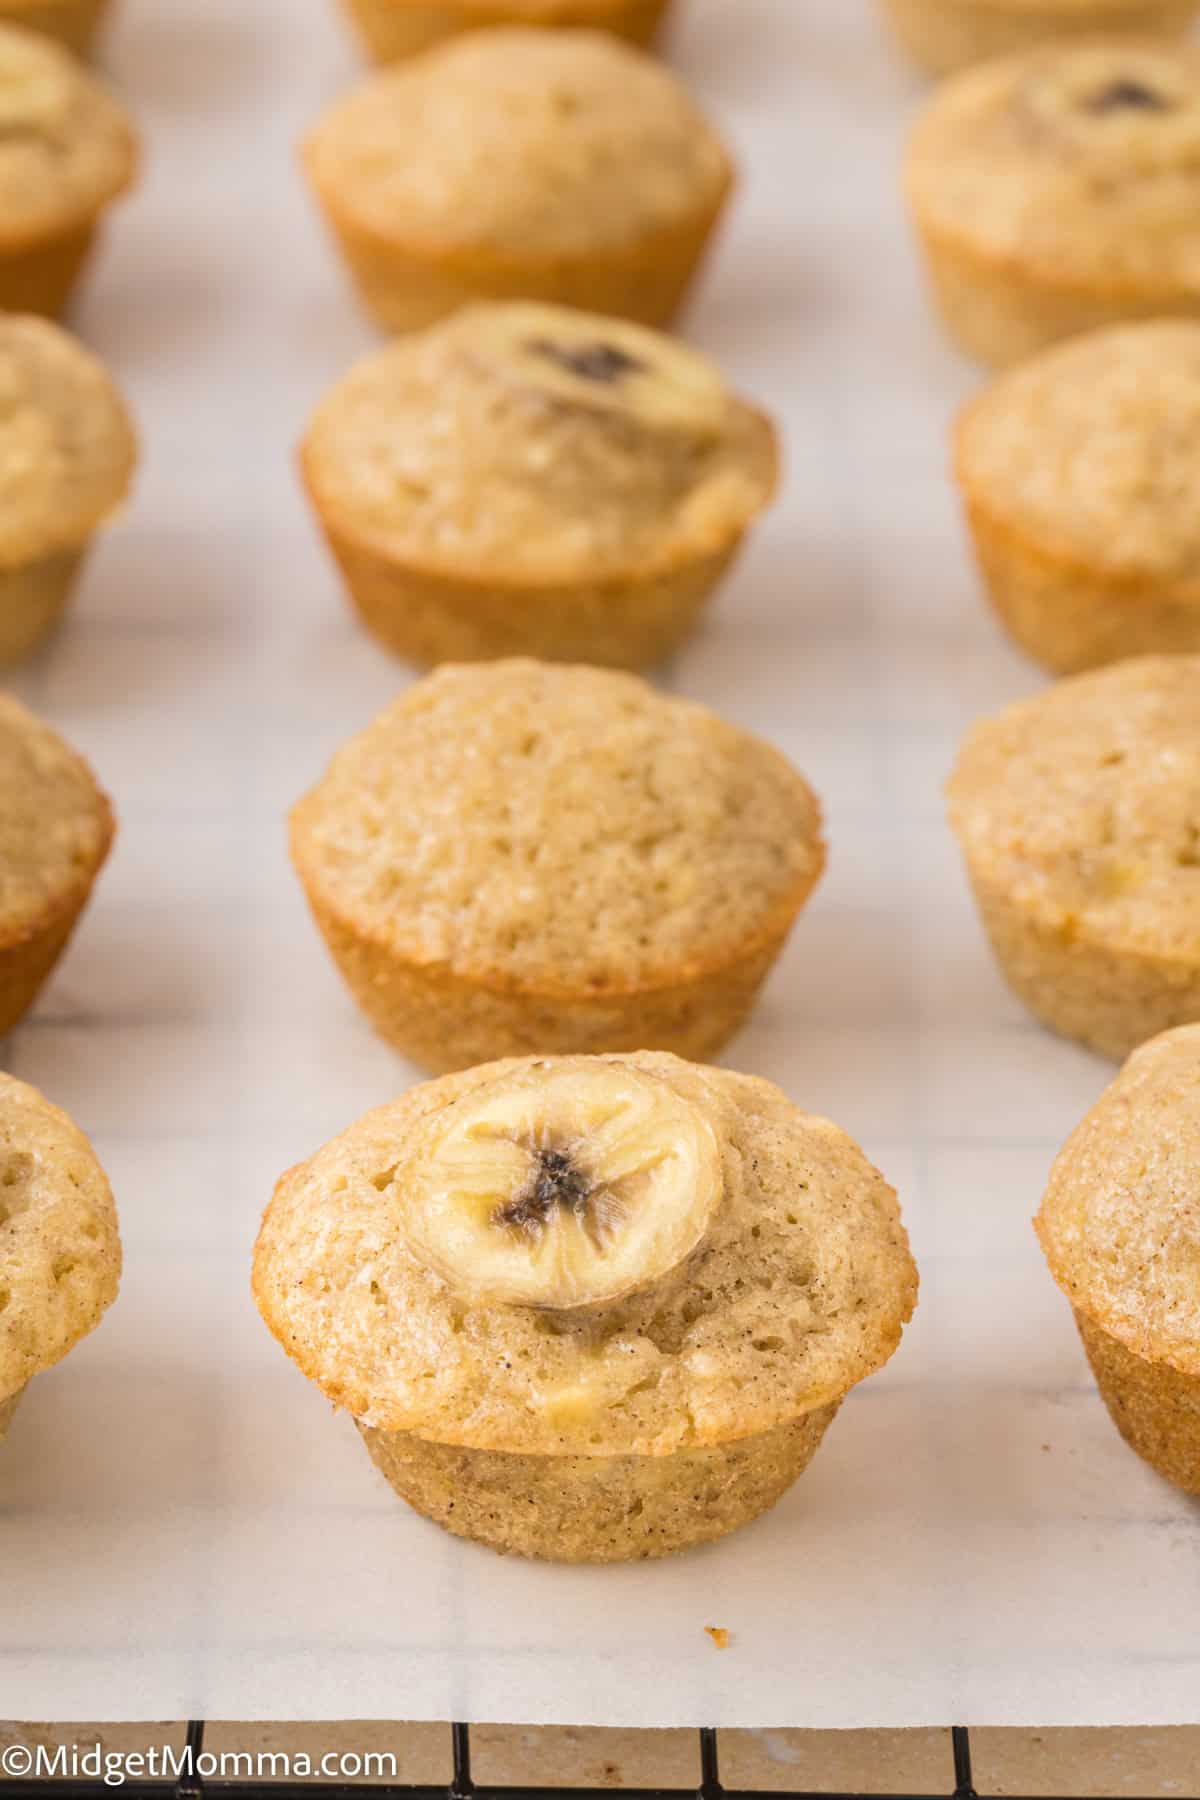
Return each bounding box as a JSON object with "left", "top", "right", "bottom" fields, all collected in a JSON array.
[{"left": 1076, "top": 1312, "right": 1200, "bottom": 1494}]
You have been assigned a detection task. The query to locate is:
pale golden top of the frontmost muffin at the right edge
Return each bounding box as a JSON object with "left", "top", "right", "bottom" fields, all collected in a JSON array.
[{"left": 1036, "top": 1024, "right": 1200, "bottom": 1375}]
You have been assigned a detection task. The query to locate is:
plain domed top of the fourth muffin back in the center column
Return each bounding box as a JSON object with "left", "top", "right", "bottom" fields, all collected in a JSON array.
[{"left": 306, "top": 25, "right": 730, "bottom": 257}]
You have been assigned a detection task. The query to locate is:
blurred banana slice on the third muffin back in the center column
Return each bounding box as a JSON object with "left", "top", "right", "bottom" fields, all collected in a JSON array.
[{"left": 453, "top": 302, "right": 729, "bottom": 441}]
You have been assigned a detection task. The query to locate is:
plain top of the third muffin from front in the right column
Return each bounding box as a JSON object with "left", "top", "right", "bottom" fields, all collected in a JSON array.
[{"left": 955, "top": 319, "right": 1200, "bottom": 603}]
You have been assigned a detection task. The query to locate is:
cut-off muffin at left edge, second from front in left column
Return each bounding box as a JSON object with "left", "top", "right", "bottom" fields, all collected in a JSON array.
[{"left": 0, "top": 695, "right": 113, "bottom": 1037}]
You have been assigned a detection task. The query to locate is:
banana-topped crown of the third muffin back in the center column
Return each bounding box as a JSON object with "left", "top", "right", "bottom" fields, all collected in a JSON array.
[{"left": 302, "top": 302, "right": 777, "bottom": 581}]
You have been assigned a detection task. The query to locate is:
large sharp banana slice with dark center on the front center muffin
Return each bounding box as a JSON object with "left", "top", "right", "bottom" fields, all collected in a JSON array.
[{"left": 403, "top": 1057, "right": 721, "bottom": 1309}]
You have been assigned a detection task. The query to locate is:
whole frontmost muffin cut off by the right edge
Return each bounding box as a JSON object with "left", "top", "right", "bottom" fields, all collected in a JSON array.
[{"left": 1036, "top": 1026, "right": 1200, "bottom": 1494}]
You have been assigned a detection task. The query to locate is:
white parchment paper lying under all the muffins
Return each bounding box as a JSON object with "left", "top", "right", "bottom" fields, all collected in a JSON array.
[{"left": 0, "top": 0, "right": 1200, "bottom": 1726}]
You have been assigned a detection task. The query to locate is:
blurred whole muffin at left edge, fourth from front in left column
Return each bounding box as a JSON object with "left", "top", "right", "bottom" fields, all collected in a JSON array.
[{"left": 0, "top": 25, "right": 137, "bottom": 315}]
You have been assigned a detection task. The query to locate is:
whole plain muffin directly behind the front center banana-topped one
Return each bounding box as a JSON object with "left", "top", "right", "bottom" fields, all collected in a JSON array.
[{"left": 291, "top": 661, "right": 824, "bottom": 1071}]
